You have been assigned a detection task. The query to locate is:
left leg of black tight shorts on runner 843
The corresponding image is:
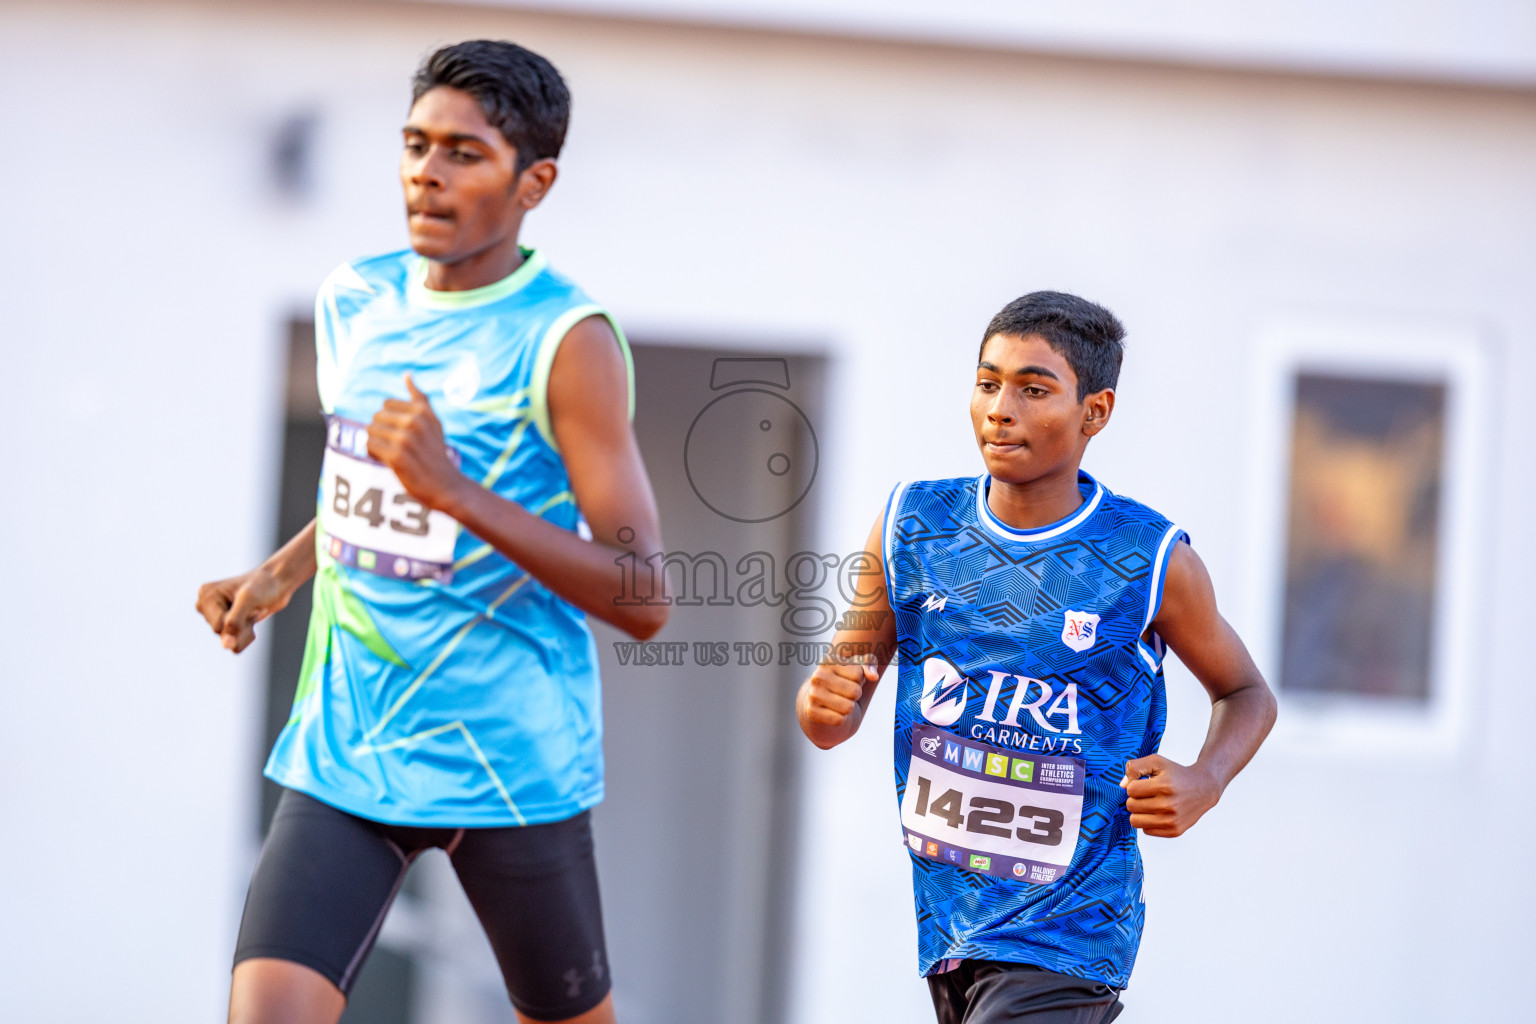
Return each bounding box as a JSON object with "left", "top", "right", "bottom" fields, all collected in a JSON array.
[{"left": 235, "top": 789, "right": 412, "bottom": 993}]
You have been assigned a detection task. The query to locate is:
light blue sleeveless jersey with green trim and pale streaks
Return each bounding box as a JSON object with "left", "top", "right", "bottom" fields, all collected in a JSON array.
[{"left": 266, "top": 250, "right": 634, "bottom": 827}]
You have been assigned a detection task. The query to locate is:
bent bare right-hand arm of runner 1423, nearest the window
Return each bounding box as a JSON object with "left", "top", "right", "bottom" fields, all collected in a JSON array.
[{"left": 1120, "top": 543, "right": 1275, "bottom": 837}]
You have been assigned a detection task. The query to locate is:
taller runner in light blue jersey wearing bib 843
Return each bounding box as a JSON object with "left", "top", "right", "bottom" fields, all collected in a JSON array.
[{"left": 198, "top": 40, "right": 667, "bottom": 1024}]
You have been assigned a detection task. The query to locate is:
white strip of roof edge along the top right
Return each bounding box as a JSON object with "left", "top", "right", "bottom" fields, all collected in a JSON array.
[{"left": 448, "top": 0, "right": 1536, "bottom": 84}]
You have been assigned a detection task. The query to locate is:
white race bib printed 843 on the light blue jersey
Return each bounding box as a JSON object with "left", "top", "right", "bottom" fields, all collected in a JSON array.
[{"left": 311, "top": 416, "right": 459, "bottom": 582}]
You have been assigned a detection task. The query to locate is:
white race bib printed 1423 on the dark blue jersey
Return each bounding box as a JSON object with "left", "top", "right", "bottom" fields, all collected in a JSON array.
[{"left": 902, "top": 725, "right": 1084, "bottom": 884}]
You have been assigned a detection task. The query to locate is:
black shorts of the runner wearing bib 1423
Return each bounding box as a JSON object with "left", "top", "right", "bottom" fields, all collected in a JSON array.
[{"left": 928, "top": 960, "right": 1124, "bottom": 1024}]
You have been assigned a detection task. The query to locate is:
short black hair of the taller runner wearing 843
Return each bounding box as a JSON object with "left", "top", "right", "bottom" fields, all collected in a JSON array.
[{"left": 410, "top": 38, "right": 571, "bottom": 173}]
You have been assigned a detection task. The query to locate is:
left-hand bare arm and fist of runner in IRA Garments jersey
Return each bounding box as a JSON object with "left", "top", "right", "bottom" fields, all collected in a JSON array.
[{"left": 794, "top": 516, "right": 895, "bottom": 751}]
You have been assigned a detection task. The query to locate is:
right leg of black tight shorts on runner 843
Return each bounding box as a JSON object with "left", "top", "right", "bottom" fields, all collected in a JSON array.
[{"left": 453, "top": 812, "right": 610, "bottom": 1021}]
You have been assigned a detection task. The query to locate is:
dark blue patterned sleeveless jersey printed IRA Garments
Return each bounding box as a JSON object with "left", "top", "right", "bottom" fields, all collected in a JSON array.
[{"left": 885, "top": 473, "right": 1184, "bottom": 986}]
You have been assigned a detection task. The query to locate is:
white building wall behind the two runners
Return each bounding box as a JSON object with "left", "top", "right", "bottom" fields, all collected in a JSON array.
[{"left": 0, "top": 3, "right": 1536, "bottom": 1024}]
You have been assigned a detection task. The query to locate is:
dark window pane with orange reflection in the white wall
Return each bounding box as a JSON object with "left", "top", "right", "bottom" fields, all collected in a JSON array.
[{"left": 1279, "top": 373, "right": 1445, "bottom": 703}]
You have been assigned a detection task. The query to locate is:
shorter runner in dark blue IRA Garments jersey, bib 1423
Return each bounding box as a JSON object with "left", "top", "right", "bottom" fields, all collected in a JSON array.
[{"left": 796, "top": 292, "right": 1275, "bottom": 1024}]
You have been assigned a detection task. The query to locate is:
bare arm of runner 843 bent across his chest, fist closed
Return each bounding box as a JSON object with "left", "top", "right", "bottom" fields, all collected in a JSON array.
[{"left": 369, "top": 316, "right": 668, "bottom": 640}]
